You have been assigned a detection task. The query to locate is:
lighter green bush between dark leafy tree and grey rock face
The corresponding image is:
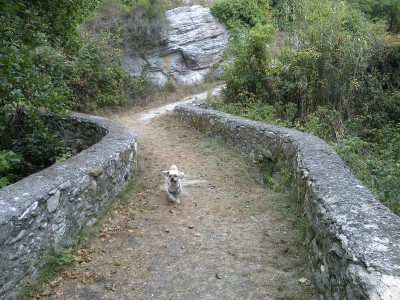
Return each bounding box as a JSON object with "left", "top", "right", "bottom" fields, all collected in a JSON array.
[{"left": 67, "top": 33, "right": 129, "bottom": 112}]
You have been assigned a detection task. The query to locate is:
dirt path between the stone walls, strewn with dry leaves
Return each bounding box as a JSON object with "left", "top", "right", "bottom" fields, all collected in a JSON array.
[{"left": 37, "top": 91, "right": 316, "bottom": 300}]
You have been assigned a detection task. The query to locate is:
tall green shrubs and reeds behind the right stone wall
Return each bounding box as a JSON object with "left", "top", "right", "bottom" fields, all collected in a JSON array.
[{"left": 218, "top": 0, "right": 400, "bottom": 214}]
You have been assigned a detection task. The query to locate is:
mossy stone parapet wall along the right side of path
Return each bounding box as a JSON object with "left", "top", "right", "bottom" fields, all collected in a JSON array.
[{"left": 175, "top": 105, "right": 400, "bottom": 300}]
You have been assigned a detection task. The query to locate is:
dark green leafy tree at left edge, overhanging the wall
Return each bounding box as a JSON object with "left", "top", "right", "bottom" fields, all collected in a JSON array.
[{"left": 0, "top": 0, "right": 98, "bottom": 184}]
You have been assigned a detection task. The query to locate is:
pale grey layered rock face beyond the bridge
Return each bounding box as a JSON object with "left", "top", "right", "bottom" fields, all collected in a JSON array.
[{"left": 125, "top": 5, "right": 229, "bottom": 85}]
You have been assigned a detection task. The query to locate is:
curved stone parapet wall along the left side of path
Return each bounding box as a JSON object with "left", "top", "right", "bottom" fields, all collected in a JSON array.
[{"left": 0, "top": 114, "right": 137, "bottom": 299}]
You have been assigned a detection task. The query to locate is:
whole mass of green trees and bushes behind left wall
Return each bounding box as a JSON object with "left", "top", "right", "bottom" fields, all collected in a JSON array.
[{"left": 0, "top": 0, "right": 150, "bottom": 186}]
